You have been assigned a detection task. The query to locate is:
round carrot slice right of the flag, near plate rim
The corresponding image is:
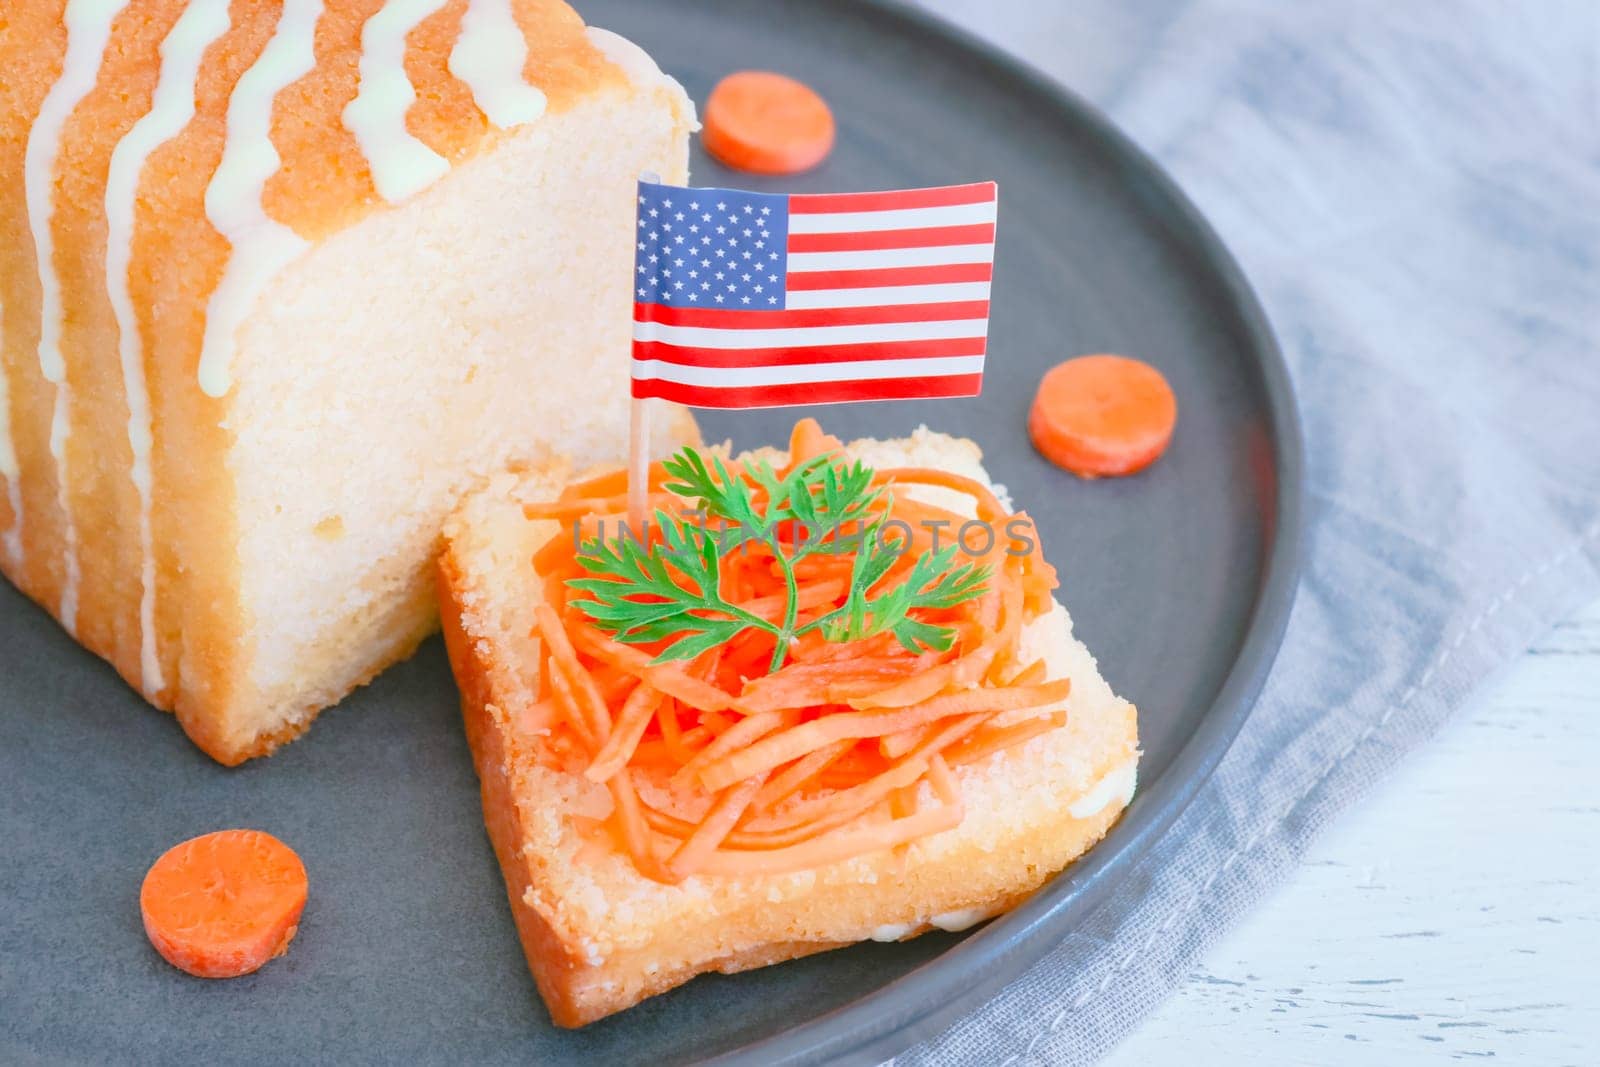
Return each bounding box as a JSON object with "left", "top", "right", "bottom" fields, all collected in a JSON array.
[{"left": 1027, "top": 355, "right": 1178, "bottom": 478}]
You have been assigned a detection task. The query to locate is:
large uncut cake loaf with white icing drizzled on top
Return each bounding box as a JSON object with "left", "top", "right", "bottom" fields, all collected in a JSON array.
[{"left": 0, "top": 0, "right": 694, "bottom": 763}]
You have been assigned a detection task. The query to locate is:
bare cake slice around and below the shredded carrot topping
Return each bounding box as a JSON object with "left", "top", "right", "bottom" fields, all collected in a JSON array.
[{"left": 438, "top": 434, "right": 1138, "bottom": 1027}]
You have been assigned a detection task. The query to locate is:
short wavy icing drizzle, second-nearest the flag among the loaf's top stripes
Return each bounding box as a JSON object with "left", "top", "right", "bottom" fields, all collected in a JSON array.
[{"left": 342, "top": 0, "right": 450, "bottom": 203}]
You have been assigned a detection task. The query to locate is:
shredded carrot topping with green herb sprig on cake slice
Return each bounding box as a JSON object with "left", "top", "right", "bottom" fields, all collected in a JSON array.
[{"left": 526, "top": 419, "right": 1070, "bottom": 883}]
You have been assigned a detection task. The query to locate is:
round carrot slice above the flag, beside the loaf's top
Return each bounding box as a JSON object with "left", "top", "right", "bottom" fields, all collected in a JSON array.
[{"left": 701, "top": 70, "right": 834, "bottom": 174}]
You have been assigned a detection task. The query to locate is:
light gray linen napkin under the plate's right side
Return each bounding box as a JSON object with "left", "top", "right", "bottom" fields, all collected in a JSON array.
[{"left": 901, "top": 0, "right": 1600, "bottom": 1064}]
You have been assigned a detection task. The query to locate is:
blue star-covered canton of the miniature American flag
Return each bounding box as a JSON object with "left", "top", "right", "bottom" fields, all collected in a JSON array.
[{"left": 634, "top": 182, "right": 789, "bottom": 312}]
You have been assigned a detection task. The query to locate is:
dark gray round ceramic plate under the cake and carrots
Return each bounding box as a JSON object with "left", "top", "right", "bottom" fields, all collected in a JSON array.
[{"left": 0, "top": 0, "right": 1299, "bottom": 1064}]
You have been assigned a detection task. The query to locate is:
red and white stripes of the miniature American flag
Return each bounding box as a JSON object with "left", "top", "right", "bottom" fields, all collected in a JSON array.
[{"left": 634, "top": 182, "right": 995, "bottom": 408}]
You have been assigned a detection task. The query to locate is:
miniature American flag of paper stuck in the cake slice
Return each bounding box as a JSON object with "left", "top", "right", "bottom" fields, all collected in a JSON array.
[{"left": 634, "top": 182, "right": 995, "bottom": 408}]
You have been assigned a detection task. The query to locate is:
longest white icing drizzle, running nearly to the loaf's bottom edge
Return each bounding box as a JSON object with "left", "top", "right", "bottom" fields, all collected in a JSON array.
[{"left": 106, "top": 3, "right": 229, "bottom": 694}]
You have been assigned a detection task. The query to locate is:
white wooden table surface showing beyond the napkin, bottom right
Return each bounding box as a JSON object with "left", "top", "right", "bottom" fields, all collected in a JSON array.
[{"left": 1106, "top": 601, "right": 1600, "bottom": 1067}]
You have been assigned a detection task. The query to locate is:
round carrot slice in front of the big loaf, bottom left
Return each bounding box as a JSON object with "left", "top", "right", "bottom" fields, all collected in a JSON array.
[{"left": 139, "top": 830, "right": 306, "bottom": 977}]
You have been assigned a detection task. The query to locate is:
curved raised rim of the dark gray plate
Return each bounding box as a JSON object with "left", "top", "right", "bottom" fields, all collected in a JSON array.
[{"left": 704, "top": 0, "right": 1306, "bottom": 1064}]
